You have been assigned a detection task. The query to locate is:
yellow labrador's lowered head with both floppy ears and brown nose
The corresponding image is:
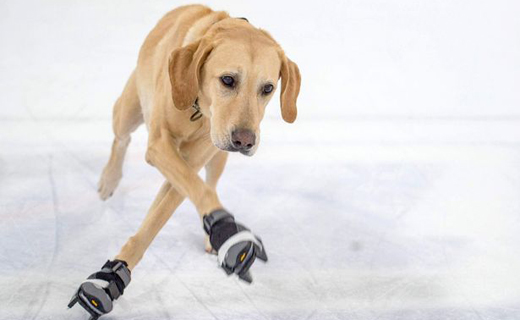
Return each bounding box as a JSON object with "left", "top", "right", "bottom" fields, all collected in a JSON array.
[{"left": 169, "top": 19, "right": 300, "bottom": 155}]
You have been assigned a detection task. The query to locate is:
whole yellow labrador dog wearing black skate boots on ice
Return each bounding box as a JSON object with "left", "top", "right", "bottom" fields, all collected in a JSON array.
[{"left": 71, "top": 5, "right": 300, "bottom": 318}]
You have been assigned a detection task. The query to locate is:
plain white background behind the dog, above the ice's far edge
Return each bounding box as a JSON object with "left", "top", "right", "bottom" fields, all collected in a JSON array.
[{"left": 0, "top": 0, "right": 520, "bottom": 119}]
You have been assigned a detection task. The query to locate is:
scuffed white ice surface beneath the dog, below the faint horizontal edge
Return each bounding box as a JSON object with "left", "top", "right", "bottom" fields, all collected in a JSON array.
[{"left": 0, "top": 119, "right": 520, "bottom": 320}]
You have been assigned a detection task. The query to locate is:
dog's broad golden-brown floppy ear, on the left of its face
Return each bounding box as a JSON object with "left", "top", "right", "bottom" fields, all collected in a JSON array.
[{"left": 168, "top": 39, "right": 213, "bottom": 110}]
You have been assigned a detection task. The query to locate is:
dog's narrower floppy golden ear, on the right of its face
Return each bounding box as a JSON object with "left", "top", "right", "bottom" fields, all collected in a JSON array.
[{"left": 280, "top": 53, "right": 301, "bottom": 123}]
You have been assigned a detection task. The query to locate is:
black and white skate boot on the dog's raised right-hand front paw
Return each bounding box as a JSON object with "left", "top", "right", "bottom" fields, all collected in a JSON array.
[{"left": 203, "top": 210, "right": 267, "bottom": 283}]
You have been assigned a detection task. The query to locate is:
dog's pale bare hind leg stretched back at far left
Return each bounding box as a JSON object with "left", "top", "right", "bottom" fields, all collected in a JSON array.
[{"left": 98, "top": 71, "right": 144, "bottom": 200}]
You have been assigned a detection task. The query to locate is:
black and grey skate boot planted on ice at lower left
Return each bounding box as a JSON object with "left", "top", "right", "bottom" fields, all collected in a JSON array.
[{"left": 69, "top": 260, "right": 131, "bottom": 320}]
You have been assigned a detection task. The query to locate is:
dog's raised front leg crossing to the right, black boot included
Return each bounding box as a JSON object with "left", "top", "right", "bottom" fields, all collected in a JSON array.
[{"left": 146, "top": 131, "right": 267, "bottom": 282}]
